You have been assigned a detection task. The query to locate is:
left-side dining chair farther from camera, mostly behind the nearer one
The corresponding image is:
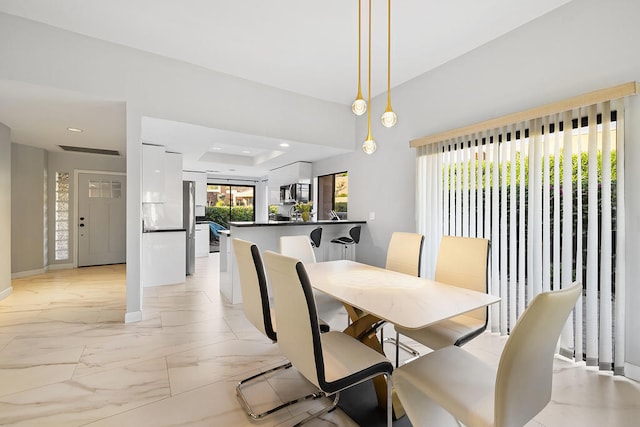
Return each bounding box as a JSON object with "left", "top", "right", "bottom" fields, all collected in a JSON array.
[{"left": 233, "top": 238, "right": 320, "bottom": 419}]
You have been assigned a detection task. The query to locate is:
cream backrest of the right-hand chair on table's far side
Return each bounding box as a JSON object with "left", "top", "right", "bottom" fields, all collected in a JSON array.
[{"left": 434, "top": 236, "right": 489, "bottom": 321}]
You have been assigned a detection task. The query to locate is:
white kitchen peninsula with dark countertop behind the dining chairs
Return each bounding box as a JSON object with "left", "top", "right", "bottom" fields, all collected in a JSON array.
[{"left": 220, "top": 220, "right": 367, "bottom": 304}]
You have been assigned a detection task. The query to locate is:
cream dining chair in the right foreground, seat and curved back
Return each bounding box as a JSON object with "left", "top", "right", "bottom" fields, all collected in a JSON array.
[{"left": 393, "top": 283, "right": 582, "bottom": 427}]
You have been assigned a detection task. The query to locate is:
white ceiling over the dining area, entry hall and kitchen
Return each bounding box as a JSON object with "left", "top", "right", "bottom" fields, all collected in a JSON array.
[{"left": 0, "top": 0, "right": 569, "bottom": 176}]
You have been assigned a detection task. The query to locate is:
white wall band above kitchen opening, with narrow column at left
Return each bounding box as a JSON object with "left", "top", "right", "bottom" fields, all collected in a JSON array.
[{"left": 0, "top": 14, "right": 354, "bottom": 320}]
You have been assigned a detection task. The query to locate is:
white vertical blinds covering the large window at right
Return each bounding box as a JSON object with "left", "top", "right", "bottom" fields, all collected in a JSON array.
[{"left": 416, "top": 100, "right": 625, "bottom": 374}]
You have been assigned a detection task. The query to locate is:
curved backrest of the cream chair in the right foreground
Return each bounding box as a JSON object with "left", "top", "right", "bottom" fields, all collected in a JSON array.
[{"left": 494, "top": 282, "right": 582, "bottom": 427}]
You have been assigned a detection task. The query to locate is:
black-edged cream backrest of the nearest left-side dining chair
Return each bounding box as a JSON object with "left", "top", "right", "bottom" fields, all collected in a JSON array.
[{"left": 264, "top": 251, "right": 325, "bottom": 389}]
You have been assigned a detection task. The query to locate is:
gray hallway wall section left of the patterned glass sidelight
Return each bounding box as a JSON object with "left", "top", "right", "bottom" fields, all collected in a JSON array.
[{"left": 11, "top": 144, "right": 47, "bottom": 274}]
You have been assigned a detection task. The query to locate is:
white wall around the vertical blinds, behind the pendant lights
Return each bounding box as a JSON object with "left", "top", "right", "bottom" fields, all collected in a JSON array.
[{"left": 314, "top": 0, "right": 640, "bottom": 379}]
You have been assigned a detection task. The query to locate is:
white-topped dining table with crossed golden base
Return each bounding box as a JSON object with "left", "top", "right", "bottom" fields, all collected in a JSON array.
[{"left": 305, "top": 260, "right": 500, "bottom": 419}]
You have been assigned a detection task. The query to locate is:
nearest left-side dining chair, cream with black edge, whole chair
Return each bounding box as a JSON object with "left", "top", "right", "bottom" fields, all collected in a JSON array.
[{"left": 264, "top": 251, "right": 393, "bottom": 427}]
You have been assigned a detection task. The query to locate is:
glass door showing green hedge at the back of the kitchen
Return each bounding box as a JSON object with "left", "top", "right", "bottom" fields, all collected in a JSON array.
[{"left": 205, "top": 184, "right": 255, "bottom": 228}]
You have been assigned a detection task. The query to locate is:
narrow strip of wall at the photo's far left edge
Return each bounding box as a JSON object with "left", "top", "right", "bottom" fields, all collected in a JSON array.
[{"left": 0, "top": 123, "right": 11, "bottom": 300}]
